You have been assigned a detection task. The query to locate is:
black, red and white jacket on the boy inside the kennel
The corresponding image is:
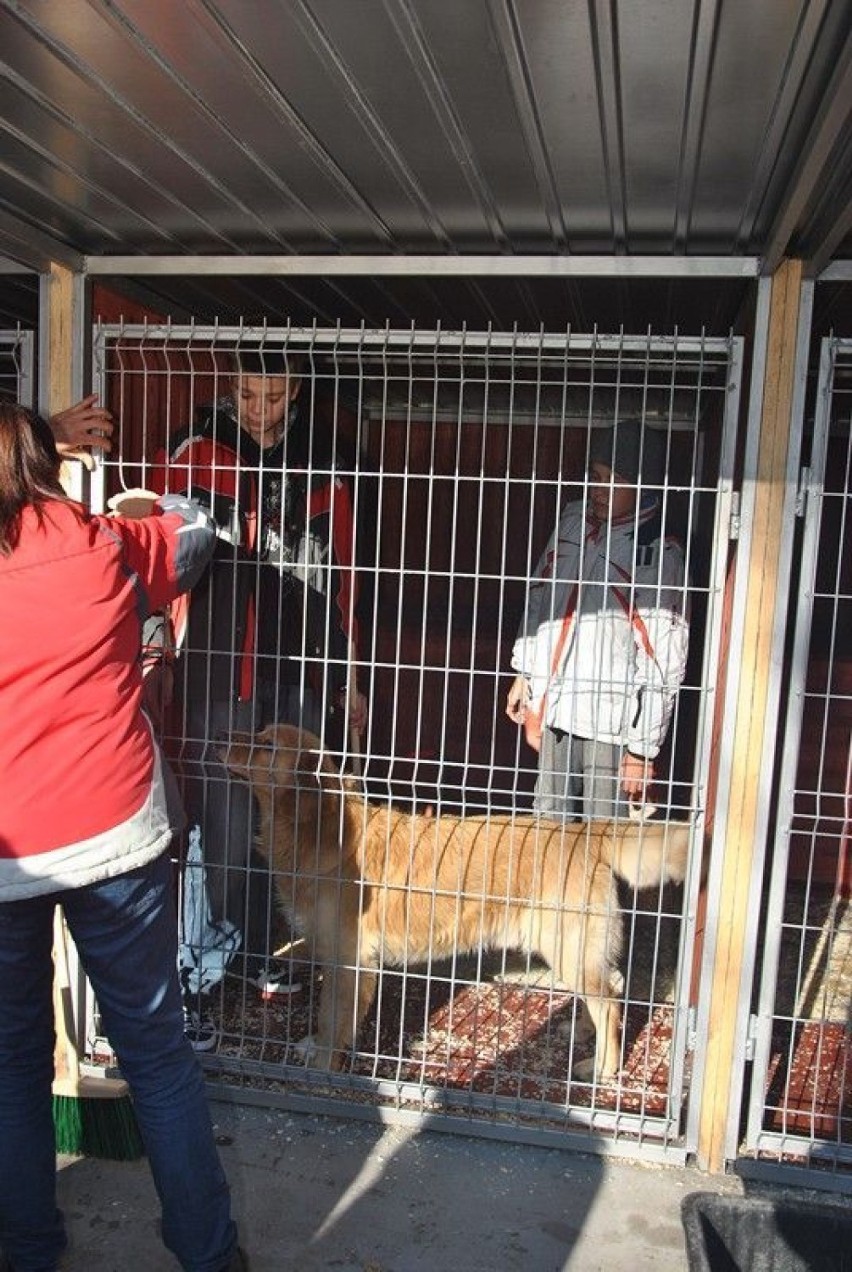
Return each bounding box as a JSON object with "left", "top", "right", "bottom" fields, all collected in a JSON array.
[{"left": 150, "top": 398, "right": 357, "bottom": 702}]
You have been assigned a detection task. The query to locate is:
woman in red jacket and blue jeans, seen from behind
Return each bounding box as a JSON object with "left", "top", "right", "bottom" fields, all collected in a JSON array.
[{"left": 0, "top": 403, "right": 245, "bottom": 1272}]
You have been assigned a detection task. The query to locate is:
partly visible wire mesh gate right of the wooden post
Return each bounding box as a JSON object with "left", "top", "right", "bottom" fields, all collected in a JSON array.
[{"left": 745, "top": 340, "right": 852, "bottom": 1187}]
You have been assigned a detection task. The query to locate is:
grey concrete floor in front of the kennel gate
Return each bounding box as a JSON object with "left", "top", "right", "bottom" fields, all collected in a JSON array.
[{"left": 46, "top": 1102, "right": 778, "bottom": 1272}]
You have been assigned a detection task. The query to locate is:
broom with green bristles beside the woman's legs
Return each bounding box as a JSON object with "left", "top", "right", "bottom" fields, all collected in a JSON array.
[{"left": 53, "top": 906, "right": 145, "bottom": 1161}]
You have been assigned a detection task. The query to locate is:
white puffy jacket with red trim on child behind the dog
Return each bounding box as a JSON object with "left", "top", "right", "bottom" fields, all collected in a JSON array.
[{"left": 511, "top": 501, "right": 689, "bottom": 759}]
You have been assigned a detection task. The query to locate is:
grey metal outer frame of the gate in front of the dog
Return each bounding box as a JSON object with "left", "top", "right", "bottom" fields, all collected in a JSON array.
[{"left": 89, "top": 323, "right": 744, "bottom": 1161}]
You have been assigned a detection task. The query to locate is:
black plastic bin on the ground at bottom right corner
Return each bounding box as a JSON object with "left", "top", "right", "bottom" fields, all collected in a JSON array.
[{"left": 680, "top": 1193, "right": 852, "bottom": 1272}]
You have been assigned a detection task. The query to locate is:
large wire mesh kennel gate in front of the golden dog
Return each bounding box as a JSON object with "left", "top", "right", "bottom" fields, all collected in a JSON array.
[{"left": 93, "top": 326, "right": 741, "bottom": 1152}]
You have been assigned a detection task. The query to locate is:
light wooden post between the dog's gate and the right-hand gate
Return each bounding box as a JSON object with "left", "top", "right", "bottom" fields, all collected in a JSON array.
[{"left": 698, "top": 261, "right": 802, "bottom": 1172}]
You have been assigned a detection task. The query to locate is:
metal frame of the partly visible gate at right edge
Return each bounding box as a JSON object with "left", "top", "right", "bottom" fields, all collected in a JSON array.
[{"left": 743, "top": 337, "right": 852, "bottom": 1191}]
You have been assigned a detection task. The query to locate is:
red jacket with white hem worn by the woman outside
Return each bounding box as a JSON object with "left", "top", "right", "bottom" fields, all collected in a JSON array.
[{"left": 0, "top": 497, "right": 216, "bottom": 901}]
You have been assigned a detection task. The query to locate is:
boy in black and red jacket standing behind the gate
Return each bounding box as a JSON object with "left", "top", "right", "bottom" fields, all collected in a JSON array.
[{"left": 150, "top": 343, "right": 366, "bottom": 1049}]
